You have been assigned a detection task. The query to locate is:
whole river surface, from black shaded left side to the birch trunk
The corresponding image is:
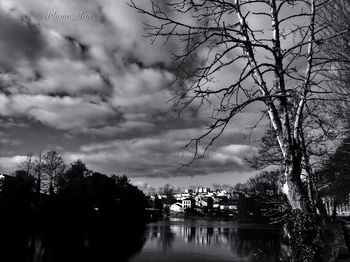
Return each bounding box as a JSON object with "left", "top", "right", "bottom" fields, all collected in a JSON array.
[{"left": 0, "top": 218, "right": 284, "bottom": 262}]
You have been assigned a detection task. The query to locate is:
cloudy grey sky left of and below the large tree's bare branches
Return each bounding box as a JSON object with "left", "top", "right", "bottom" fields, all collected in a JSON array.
[{"left": 0, "top": 0, "right": 270, "bottom": 190}]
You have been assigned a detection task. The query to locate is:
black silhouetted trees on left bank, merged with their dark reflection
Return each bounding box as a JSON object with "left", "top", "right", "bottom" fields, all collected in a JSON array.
[{"left": 0, "top": 151, "right": 147, "bottom": 261}]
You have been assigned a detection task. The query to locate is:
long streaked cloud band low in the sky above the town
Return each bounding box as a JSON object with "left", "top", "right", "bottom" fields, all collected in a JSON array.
[{"left": 67, "top": 132, "right": 254, "bottom": 178}]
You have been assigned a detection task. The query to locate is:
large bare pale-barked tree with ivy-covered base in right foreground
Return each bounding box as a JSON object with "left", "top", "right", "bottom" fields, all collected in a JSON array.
[{"left": 130, "top": 0, "right": 348, "bottom": 261}]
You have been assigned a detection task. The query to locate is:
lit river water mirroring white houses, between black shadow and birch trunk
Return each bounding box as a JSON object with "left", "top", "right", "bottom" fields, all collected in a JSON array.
[{"left": 130, "top": 218, "right": 282, "bottom": 262}]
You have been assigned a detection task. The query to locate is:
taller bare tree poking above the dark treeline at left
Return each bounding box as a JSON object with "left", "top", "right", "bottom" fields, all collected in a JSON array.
[{"left": 43, "top": 150, "right": 66, "bottom": 195}]
